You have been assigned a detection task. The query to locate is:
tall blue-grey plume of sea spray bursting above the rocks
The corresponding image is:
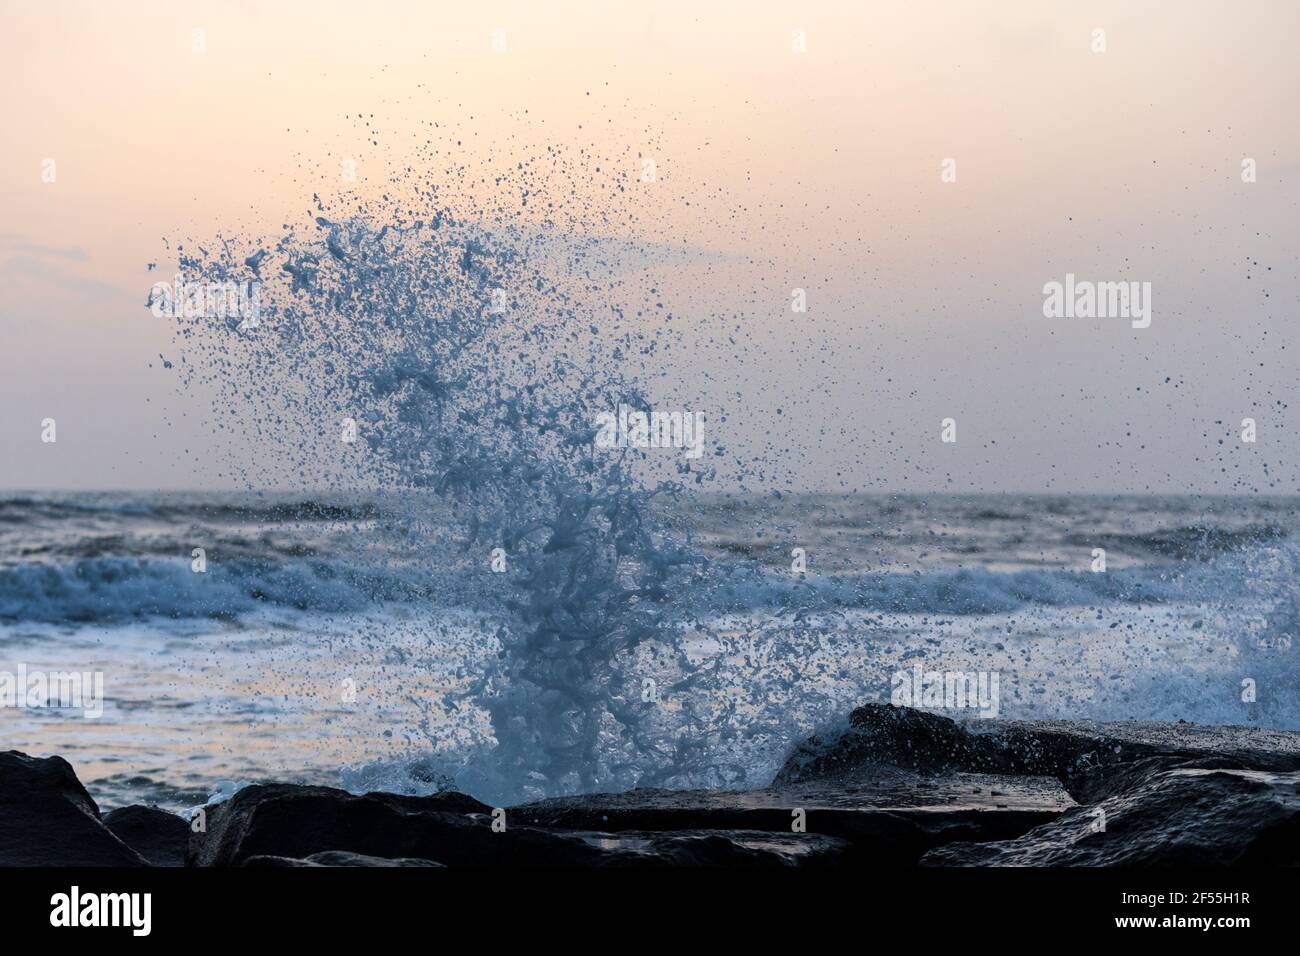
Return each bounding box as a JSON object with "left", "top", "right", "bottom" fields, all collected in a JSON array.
[{"left": 159, "top": 179, "right": 754, "bottom": 799}]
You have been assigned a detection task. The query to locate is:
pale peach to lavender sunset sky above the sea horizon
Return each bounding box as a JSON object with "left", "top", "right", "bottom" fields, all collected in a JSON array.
[{"left": 0, "top": 0, "right": 1300, "bottom": 493}]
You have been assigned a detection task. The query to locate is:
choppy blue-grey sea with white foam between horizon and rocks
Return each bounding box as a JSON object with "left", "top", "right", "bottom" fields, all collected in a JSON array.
[{"left": 0, "top": 490, "right": 1300, "bottom": 808}]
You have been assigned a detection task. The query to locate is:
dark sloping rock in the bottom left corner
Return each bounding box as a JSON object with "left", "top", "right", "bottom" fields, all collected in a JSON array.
[{"left": 0, "top": 750, "right": 148, "bottom": 866}]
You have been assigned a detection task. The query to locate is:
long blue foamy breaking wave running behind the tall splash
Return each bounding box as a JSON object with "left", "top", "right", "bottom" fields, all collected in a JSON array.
[{"left": 0, "top": 546, "right": 1253, "bottom": 623}]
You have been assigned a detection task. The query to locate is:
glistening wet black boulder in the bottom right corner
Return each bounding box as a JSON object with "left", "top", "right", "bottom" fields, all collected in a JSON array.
[{"left": 922, "top": 758, "right": 1300, "bottom": 866}]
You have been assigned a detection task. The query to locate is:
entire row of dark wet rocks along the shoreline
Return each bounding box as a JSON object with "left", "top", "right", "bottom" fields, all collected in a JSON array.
[{"left": 0, "top": 704, "right": 1300, "bottom": 868}]
